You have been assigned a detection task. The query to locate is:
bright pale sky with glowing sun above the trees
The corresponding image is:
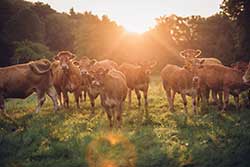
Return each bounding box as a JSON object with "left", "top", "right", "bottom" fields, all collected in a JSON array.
[{"left": 28, "top": 0, "right": 222, "bottom": 33}]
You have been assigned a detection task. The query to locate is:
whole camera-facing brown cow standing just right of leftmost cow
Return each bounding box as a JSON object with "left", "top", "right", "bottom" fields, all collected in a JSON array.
[{"left": 52, "top": 51, "right": 81, "bottom": 108}]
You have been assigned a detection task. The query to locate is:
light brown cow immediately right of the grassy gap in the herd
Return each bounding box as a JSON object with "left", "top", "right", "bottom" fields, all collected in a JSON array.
[{"left": 161, "top": 64, "right": 199, "bottom": 113}]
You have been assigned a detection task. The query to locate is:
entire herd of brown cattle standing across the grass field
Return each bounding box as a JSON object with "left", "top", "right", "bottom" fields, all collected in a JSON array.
[{"left": 0, "top": 49, "right": 250, "bottom": 127}]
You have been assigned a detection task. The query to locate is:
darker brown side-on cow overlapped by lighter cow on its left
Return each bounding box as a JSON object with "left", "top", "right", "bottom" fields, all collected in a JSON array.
[{"left": 187, "top": 60, "right": 249, "bottom": 111}]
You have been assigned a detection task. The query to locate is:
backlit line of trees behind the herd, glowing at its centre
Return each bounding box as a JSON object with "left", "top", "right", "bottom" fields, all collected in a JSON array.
[{"left": 0, "top": 0, "right": 250, "bottom": 68}]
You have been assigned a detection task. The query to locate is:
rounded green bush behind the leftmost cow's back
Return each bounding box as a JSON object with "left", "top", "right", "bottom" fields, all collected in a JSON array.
[{"left": 11, "top": 41, "right": 53, "bottom": 64}]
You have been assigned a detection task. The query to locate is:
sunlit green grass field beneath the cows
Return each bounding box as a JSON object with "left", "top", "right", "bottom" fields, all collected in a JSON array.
[{"left": 0, "top": 77, "right": 250, "bottom": 167}]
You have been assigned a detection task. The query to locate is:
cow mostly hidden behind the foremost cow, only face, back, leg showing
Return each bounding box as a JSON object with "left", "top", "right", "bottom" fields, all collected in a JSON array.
[{"left": 75, "top": 57, "right": 118, "bottom": 114}]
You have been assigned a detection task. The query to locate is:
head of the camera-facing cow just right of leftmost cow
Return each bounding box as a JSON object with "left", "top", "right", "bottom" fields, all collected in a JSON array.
[{"left": 54, "top": 51, "right": 75, "bottom": 71}]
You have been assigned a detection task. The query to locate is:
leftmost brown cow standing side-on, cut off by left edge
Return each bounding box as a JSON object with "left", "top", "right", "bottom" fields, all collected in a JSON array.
[{"left": 0, "top": 59, "right": 58, "bottom": 112}]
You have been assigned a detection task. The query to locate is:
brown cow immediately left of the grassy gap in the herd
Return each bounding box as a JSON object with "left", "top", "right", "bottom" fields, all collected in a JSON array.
[{"left": 118, "top": 62, "right": 157, "bottom": 107}]
